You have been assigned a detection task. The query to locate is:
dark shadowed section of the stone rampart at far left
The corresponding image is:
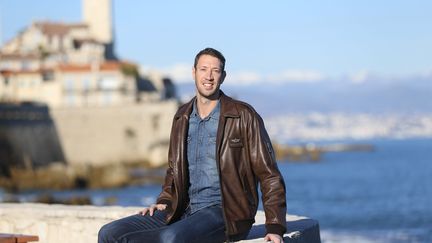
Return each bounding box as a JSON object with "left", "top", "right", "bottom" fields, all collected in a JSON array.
[{"left": 0, "top": 103, "right": 66, "bottom": 176}]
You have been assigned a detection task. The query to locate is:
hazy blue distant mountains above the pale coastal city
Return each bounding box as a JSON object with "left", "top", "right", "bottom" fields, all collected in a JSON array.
[{"left": 177, "top": 78, "right": 432, "bottom": 117}]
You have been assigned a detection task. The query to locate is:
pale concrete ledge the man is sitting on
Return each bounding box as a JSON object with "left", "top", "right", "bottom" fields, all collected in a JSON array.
[{"left": 0, "top": 203, "right": 320, "bottom": 243}]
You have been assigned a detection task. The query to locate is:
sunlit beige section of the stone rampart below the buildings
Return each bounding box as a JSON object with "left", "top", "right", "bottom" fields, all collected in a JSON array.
[{"left": 51, "top": 101, "right": 178, "bottom": 166}]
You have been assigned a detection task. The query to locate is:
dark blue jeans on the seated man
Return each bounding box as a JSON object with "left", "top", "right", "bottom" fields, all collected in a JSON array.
[{"left": 98, "top": 207, "right": 225, "bottom": 243}]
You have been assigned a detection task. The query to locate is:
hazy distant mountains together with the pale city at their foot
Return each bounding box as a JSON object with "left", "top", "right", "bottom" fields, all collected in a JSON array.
[{"left": 177, "top": 79, "right": 432, "bottom": 140}]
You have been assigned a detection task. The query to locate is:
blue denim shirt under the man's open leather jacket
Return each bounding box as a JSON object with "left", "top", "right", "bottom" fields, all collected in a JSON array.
[{"left": 187, "top": 101, "right": 222, "bottom": 213}]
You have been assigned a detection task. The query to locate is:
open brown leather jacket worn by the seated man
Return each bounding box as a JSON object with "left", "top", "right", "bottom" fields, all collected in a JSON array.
[{"left": 157, "top": 92, "right": 286, "bottom": 236}]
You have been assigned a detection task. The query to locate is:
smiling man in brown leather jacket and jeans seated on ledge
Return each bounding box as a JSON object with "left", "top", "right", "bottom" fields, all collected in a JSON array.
[{"left": 99, "top": 48, "right": 286, "bottom": 243}]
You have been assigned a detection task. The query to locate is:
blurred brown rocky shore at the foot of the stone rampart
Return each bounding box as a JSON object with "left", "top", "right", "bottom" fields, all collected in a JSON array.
[{"left": 0, "top": 162, "right": 165, "bottom": 205}]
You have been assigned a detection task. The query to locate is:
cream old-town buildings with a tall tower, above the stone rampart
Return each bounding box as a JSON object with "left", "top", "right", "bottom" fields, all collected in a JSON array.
[{"left": 0, "top": 0, "right": 174, "bottom": 107}]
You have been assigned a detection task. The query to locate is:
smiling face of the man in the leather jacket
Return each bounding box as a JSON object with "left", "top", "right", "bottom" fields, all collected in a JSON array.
[{"left": 192, "top": 55, "right": 225, "bottom": 99}]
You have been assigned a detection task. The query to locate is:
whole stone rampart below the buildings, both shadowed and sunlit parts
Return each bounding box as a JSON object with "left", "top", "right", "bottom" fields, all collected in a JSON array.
[{"left": 0, "top": 100, "right": 178, "bottom": 172}]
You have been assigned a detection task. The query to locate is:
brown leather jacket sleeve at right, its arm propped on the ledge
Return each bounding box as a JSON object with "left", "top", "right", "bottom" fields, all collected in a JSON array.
[{"left": 247, "top": 112, "right": 286, "bottom": 236}]
